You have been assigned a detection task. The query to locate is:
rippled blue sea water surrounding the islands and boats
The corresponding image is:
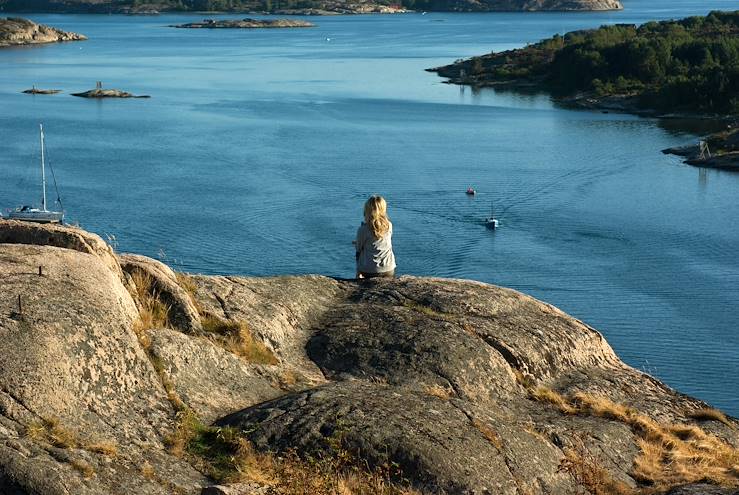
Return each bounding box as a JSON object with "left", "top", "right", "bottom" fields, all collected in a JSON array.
[{"left": 0, "top": 0, "right": 739, "bottom": 415}]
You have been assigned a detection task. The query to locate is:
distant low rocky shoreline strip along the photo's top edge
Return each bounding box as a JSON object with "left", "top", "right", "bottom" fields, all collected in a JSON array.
[{"left": 0, "top": 0, "right": 623, "bottom": 15}]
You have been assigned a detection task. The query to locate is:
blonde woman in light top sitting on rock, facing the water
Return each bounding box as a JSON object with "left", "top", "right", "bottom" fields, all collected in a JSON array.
[{"left": 354, "top": 196, "right": 395, "bottom": 278}]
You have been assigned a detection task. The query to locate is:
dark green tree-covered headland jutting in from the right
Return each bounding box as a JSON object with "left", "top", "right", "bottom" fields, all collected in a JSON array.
[{"left": 431, "top": 11, "right": 739, "bottom": 115}]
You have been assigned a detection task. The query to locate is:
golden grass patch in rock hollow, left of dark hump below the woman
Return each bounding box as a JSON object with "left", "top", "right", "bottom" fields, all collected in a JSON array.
[{"left": 201, "top": 315, "right": 278, "bottom": 365}]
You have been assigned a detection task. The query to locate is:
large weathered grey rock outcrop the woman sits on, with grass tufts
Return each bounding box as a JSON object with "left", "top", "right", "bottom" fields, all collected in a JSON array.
[{"left": 0, "top": 220, "right": 739, "bottom": 495}]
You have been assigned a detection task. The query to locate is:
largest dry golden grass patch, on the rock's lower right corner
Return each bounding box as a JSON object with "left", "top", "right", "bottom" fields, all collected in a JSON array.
[{"left": 532, "top": 387, "right": 739, "bottom": 492}]
